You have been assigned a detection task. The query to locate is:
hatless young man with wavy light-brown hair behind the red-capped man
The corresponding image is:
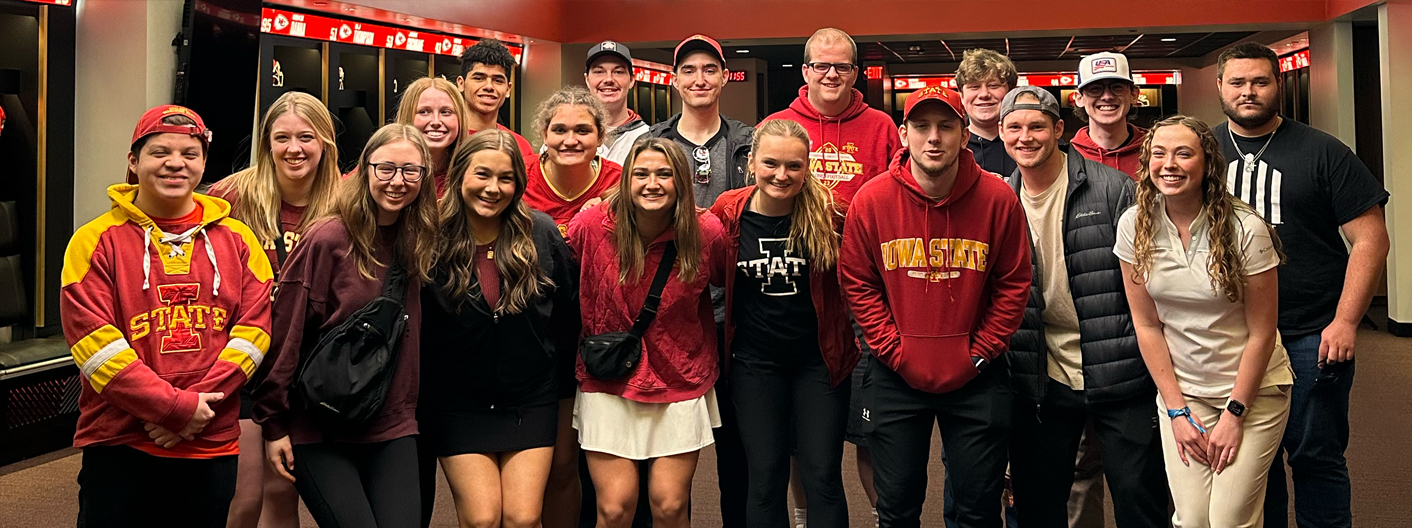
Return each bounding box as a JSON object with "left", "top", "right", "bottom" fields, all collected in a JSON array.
[{"left": 956, "top": 48, "right": 1019, "bottom": 176}]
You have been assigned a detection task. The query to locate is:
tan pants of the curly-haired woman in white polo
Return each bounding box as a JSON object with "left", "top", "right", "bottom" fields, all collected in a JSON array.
[{"left": 1156, "top": 385, "right": 1289, "bottom": 528}]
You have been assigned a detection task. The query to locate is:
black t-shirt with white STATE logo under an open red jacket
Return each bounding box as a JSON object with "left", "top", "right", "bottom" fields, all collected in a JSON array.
[{"left": 731, "top": 210, "right": 819, "bottom": 361}]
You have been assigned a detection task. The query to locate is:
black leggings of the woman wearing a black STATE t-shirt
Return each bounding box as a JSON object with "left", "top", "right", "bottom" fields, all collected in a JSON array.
[{"left": 730, "top": 352, "right": 851, "bottom": 528}]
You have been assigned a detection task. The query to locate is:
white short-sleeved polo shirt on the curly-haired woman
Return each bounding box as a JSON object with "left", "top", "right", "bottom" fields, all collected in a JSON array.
[{"left": 1113, "top": 196, "right": 1295, "bottom": 398}]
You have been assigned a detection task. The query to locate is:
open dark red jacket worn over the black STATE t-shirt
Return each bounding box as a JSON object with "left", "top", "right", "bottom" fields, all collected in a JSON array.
[{"left": 710, "top": 185, "right": 858, "bottom": 387}]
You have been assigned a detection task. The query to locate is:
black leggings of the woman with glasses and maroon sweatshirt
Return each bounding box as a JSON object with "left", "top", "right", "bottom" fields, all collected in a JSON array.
[{"left": 294, "top": 436, "right": 422, "bottom": 528}]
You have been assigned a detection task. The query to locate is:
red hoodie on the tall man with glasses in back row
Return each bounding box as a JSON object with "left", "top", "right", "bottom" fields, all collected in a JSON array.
[{"left": 761, "top": 86, "right": 902, "bottom": 200}]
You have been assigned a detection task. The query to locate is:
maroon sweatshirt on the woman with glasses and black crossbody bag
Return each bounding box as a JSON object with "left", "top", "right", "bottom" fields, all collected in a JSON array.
[{"left": 254, "top": 216, "right": 422, "bottom": 445}]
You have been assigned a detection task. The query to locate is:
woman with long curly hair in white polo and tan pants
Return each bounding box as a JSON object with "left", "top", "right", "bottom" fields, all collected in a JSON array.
[{"left": 1113, "top": 116, "right": 1293, "bottom": 527}]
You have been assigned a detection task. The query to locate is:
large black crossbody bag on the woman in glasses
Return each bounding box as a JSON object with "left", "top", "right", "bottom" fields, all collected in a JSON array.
[{"left": 295, "top": 260, "right": 408, "bottom": 426}]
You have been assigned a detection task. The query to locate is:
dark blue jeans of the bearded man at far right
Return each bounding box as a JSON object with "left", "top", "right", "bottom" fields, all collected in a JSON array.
[{"left": 1265, "top": 333, "right": 1354, "bottom": 528}]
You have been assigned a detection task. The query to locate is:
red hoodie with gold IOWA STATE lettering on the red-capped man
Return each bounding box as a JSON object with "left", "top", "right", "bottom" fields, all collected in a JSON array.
[{"left": 839, "top": 150, "right": 1031, "bottom": 394}]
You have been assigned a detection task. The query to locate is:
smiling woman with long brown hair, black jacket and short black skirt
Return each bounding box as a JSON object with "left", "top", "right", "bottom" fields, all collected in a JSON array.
[{"left": 419, "top": 130, "right": 579, "bottom": 528}]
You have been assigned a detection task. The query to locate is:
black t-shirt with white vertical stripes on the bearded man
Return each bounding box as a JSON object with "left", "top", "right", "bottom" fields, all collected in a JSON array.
[{"left": 1213, "top": 119, "right": 1388, "bottom": 336}]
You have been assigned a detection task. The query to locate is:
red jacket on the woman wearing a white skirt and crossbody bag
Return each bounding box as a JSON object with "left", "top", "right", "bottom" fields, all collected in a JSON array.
[{"left": 569, "top": 202, "right": 724, "bottom": 404}]
